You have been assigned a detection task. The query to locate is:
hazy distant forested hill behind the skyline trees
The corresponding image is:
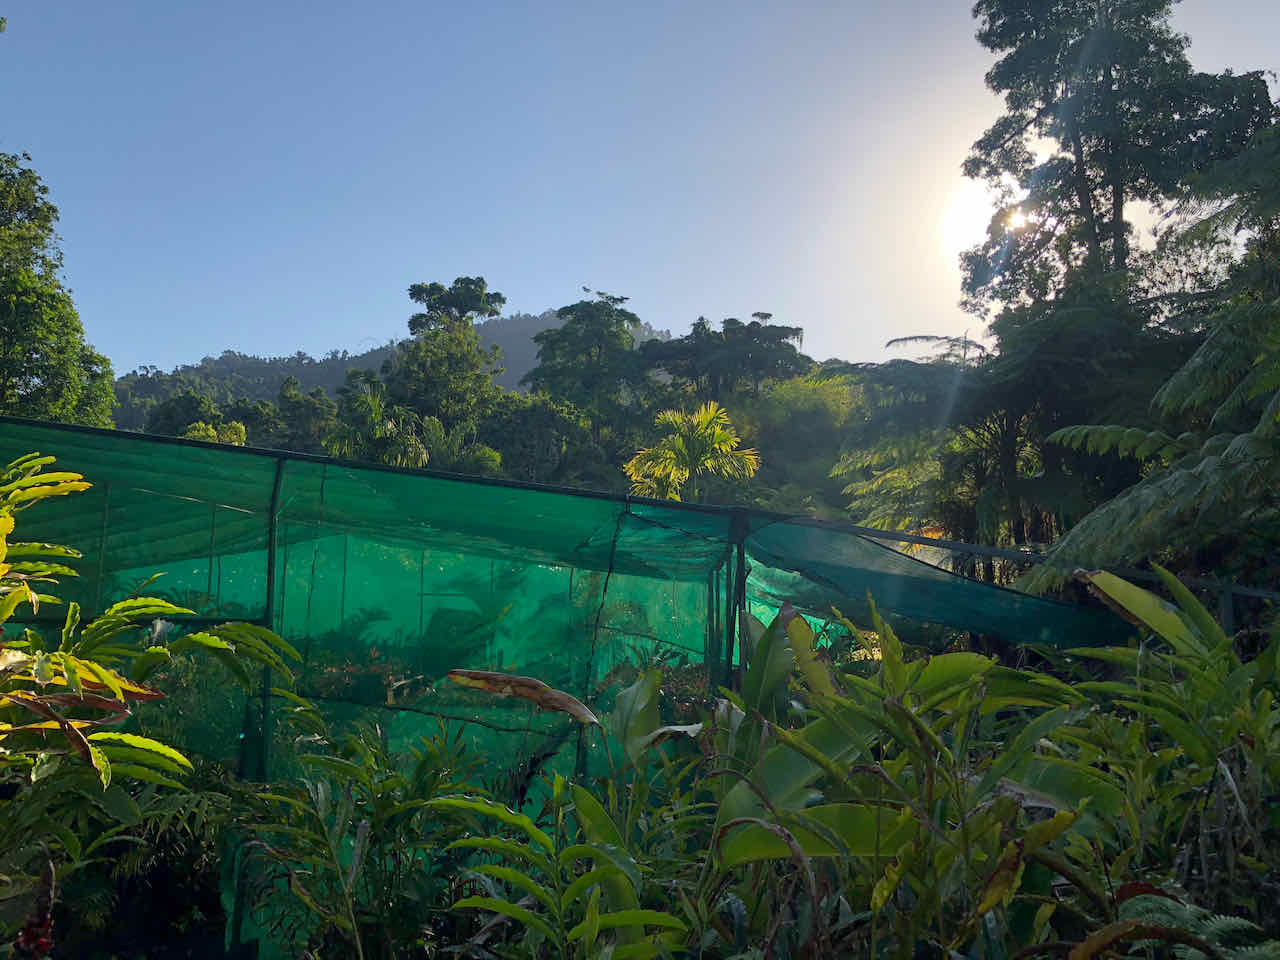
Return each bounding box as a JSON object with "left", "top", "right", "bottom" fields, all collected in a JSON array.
[{"left": 115, "top": 310, "right": 671, "bottom": 430}]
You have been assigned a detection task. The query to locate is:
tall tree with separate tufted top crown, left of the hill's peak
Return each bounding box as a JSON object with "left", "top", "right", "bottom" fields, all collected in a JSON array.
[{"left": 383, "top": 276, "right": 506, "bottom": 439}]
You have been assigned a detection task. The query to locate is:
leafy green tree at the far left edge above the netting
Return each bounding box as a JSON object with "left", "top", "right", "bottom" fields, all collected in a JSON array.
[{"left": 0, "top": 154, "right": 115, "bottom": 426}]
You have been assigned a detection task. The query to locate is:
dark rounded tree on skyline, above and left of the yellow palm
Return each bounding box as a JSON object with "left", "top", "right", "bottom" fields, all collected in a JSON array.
[{"left": 524, "top": 292, "right": 641, "bottom": 442}]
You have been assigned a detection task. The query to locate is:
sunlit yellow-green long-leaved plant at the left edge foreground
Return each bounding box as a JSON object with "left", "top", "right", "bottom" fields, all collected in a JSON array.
[{"left": 0, "top": 454, "right": 297, "bottom": 957}]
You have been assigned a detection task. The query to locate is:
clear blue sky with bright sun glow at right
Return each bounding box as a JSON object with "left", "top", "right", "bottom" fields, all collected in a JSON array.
[{"left": 0, "top": 0, "right": 1280, "bottom": 372}]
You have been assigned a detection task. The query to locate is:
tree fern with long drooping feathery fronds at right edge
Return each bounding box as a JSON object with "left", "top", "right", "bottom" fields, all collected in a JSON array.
[{"left": 1025, "top": 123, "right": 1280, "bottom": 589}]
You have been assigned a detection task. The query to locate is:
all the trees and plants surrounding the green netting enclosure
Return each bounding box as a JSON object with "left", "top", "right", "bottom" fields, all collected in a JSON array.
[{"left": 0, "top": 0, "right": 1280, "bottom": 960}]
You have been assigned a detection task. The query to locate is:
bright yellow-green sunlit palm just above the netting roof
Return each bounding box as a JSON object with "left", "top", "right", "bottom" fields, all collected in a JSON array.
[{"left": 622, "top": 401, "right": 760, "bottom": 500}]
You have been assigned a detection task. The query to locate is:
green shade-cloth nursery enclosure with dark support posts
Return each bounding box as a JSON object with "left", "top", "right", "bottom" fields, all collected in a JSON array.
[{"left": 0, "top": 417, "right": 1120, "bottom": 780}]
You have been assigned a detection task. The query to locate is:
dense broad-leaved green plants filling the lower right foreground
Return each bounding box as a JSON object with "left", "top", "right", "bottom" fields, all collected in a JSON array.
[{"left": 414, "top": 573, "right": 1280, "bottom": 957}]
